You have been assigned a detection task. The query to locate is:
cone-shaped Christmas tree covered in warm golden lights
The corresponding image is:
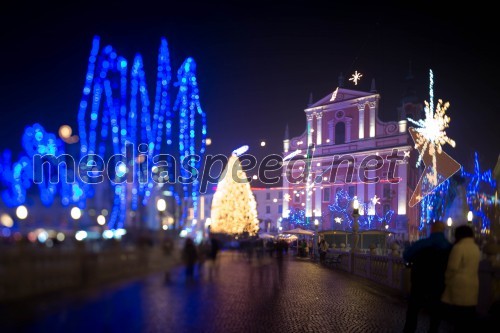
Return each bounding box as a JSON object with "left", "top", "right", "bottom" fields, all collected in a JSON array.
[{"left": 210, "top": 154, "right": 259, "bottom": 235}]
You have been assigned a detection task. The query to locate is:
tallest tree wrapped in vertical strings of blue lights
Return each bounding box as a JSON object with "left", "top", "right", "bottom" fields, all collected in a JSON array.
[{"left": 74, "top": 37, "right": 206, "bottom": 227}]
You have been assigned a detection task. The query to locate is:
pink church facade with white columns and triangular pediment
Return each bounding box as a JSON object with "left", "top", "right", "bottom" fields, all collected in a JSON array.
[{"left": 282, "top": 87, "right": 422, "bottom": 240}]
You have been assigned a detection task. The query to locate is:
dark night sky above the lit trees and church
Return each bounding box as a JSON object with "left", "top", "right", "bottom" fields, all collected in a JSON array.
[{"left": 0, "top": 1, "right": 500, "bottom": 174}]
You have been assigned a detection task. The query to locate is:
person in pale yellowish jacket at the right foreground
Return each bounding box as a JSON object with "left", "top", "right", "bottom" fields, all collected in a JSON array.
[{"left": 441, "top": 225, "right": 481, "bottom": 332}]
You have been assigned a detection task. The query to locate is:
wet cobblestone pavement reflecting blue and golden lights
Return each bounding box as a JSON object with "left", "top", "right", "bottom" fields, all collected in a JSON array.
[{"left": 0, "top": 252, "right": 458, "bottom": 333}]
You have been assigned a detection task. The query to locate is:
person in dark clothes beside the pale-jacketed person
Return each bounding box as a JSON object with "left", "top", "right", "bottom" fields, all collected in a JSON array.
[{"left": 403, "top": 221, "right": 451, "bottom": 333}]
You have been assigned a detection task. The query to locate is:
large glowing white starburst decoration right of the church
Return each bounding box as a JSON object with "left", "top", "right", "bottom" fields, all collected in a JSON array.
[{"left": 408, "top": 70, "right": 456, "bottom": 185}]
